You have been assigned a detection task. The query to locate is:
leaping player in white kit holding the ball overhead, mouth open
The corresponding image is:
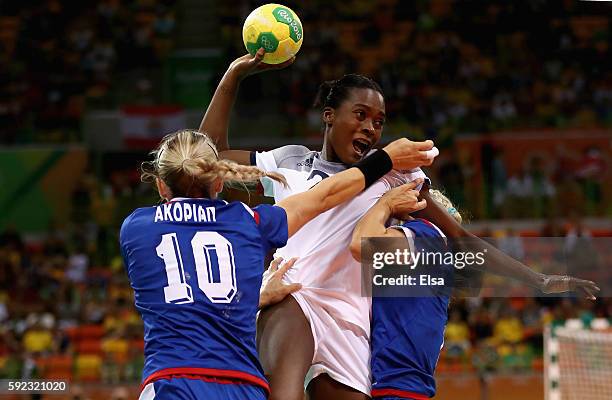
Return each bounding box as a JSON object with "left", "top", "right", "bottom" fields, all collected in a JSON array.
[{"left": 200, "top": 49, "right": 596, "bottom": 400}]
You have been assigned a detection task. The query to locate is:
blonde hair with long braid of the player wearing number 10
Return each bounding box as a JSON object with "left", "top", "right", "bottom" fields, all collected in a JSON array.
[{"left": 141, "top": 129, "right": 287, "bottom": 197}]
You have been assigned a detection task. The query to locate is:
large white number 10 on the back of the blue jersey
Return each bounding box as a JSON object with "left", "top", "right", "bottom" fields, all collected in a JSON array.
[{"left": 155, "top": 232, "right": 237, "bottom": 304}]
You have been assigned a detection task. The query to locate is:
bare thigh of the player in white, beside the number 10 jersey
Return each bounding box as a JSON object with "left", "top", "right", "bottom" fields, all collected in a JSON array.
[{"left": 257, "top": 296, "right": 314, "bottom": 400}]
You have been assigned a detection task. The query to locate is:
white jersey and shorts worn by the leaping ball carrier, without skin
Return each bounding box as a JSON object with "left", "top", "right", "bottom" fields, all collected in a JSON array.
[{"left": 254, "top": 146, "right": 425, "bottom": 397}]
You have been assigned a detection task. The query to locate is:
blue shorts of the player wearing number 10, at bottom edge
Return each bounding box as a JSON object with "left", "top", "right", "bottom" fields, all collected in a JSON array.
[{"left": 139, "top": 378, "right": 268, "bottom": 400}]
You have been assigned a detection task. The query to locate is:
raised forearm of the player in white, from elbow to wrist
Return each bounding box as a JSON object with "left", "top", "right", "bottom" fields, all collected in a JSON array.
[{"left": 199, "top": 67, "right": 240, "bottom": 152}]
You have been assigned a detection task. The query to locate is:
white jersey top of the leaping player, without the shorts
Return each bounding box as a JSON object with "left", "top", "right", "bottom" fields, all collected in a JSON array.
[{"left": 252, "top": 145, "right": 426, "bottom": 337}]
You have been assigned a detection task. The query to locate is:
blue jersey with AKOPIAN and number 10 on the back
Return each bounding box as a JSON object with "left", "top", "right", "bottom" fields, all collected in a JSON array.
[{"left": 120, "top": 199, "right": 288, "bottom": 390}]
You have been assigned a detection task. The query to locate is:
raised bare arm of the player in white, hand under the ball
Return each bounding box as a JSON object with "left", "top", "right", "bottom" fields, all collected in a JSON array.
[{"left": 199, "top": 48, "right": 295, "bottom": 165}]
